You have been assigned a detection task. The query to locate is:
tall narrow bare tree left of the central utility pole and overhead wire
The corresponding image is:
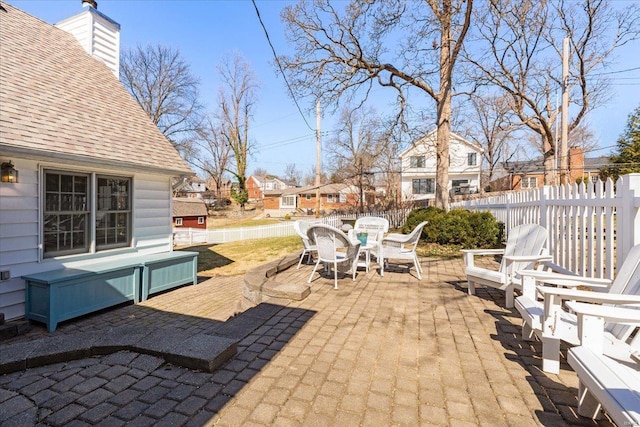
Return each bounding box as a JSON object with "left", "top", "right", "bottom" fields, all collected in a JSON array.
[{"left": 218, "top": 53, "right": 258, "bottom": 209}]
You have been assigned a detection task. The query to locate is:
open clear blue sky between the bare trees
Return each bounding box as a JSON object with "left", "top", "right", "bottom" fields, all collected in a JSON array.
[{"left": 8, "top": 0, "right": 640, "bottom": 174}]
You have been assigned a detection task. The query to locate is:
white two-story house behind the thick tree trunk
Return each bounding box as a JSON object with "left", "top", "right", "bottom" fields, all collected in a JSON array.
[{"left": 400, "top": 130, "right": 483, "bottom": 200}]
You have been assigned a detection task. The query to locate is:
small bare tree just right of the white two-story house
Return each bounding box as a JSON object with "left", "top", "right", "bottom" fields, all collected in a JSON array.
[{"left": 465, "top": 94, "right": 518, "bottom": 187}]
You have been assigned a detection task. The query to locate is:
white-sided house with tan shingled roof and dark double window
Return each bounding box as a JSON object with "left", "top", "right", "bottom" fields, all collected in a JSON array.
[{"left": 0, "top": 2, "right": 192, "bottom": 319}]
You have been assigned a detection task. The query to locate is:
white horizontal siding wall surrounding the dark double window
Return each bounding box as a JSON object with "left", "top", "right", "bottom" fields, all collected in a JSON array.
[{"left": 0, "top": 159, "right": 172, "bottom": 320}]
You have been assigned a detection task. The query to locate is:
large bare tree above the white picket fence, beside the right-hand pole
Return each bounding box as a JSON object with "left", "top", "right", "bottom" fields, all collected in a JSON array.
[{"left": 466, "top": 0, "right": 640, "bottom": 184}]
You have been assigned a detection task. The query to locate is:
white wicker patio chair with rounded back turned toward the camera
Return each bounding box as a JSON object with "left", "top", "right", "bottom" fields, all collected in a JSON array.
[{"left": 307, "top": 224, "right": 360, "bottom": 289}]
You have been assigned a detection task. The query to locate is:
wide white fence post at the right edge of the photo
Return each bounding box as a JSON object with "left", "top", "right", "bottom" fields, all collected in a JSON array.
[{"left": 607, "top": 173, "right": 640, "bottom": 265}]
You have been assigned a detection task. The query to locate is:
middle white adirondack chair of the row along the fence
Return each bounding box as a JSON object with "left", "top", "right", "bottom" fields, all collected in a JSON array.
[{"left": 515, "top": 245, "right": 640, "bottom": 374}]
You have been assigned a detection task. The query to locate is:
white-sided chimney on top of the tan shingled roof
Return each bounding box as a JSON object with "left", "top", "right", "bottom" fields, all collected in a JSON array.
[{"left": 56, "top": 0, "right": 120, "bottom": 78}]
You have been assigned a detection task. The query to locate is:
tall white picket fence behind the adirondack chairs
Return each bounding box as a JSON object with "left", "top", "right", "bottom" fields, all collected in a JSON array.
[{"left": 451, "top": 174, "right": 640, "bottom": 278}]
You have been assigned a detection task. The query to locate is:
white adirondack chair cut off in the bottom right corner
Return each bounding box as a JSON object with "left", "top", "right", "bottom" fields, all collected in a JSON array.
[{"left": 567, "top": 302, "right": 640, "bottom": 426}]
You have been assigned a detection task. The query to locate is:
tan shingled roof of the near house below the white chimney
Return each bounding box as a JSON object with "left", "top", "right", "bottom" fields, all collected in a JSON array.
[{"left": 0, "top": 2, "right": 192, "bottom": 175}]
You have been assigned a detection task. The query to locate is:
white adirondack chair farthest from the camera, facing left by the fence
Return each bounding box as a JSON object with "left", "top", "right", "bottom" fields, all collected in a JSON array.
[{"left": 462, "top": 224, "right": 551, "bottom": 308}]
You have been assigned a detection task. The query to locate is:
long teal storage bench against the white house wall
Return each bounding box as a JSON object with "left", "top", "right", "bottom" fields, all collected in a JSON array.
[{"left": 22, "top": 251, "right": 198, "bottom": 332}]
